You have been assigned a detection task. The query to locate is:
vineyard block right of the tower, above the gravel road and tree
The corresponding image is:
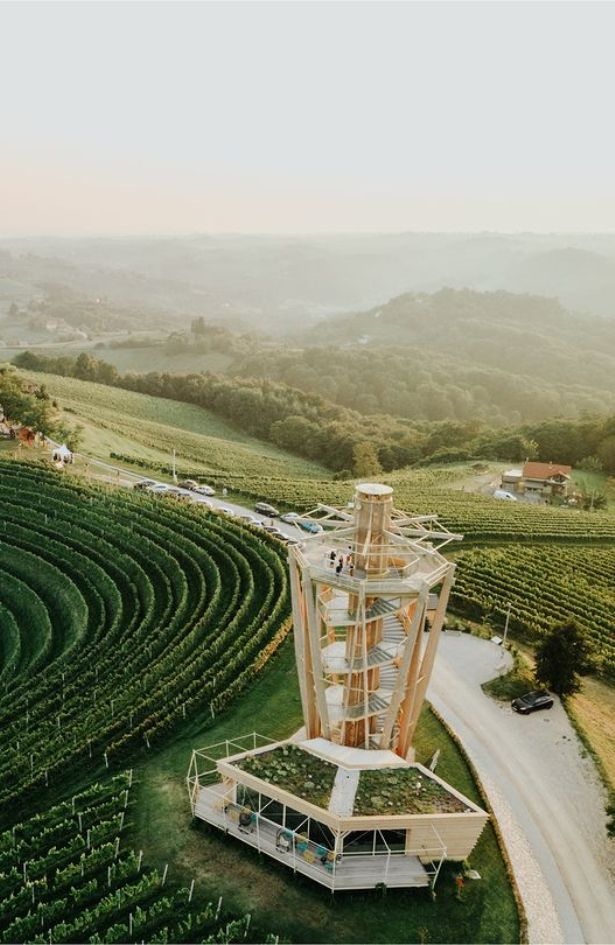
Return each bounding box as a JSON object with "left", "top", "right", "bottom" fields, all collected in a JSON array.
[{"left": 452, "top": 545, "right": 615, "bottom": 677}]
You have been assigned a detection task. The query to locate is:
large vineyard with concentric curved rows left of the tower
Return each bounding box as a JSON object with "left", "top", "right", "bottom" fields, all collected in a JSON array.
[{"left": 0, "top": 462, "right": 288, "bottom": 819}]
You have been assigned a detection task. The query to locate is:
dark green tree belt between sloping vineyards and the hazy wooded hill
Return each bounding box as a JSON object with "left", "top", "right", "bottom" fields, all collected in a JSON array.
[{"left": 12, "top": 351, "right": 615, "bottom": 478}]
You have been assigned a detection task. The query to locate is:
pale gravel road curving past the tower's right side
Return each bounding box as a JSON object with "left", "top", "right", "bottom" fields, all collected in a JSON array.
[{"left": 428, "top": 634, "right": 615, "bottom": 945}]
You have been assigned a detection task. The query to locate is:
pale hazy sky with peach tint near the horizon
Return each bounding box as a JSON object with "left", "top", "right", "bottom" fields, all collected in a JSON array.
[{"left": 0, "top": 2, "right": 615, "bottom": 234}]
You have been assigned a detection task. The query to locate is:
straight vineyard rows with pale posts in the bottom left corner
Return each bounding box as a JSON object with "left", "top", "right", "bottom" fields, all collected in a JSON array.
[{"left": 0, "top": 772, "right": 276, "bottom": 945}]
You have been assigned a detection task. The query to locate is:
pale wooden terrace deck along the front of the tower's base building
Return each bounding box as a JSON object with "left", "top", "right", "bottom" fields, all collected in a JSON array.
[{"left": 194, "top": 783, "right": 429, "bottom": 890}]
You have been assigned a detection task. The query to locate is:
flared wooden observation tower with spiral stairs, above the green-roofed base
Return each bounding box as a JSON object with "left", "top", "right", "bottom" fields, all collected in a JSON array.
[{"left": 290, "top": 483, "right": 460, "bottom": 758}]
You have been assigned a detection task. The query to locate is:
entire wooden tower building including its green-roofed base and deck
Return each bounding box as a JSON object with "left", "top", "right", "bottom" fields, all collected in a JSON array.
[{"left": 187, "top": 483, "right": 487, "bottom": 890}]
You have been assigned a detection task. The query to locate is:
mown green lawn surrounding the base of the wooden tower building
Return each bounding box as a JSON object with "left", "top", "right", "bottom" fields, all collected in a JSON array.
[{"left": 134, "top": 642, "right": 519, "bottom": 943}]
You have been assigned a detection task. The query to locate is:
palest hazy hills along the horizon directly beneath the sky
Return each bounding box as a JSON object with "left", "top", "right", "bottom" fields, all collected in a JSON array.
[{"left": 0, "top": 233, "right": 615, "bottom": 336}]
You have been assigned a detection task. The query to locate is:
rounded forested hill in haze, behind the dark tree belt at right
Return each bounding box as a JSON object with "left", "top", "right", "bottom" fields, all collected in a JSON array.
[{"left": 235, "top": 289, "right": 615, "bottom": 423}]
